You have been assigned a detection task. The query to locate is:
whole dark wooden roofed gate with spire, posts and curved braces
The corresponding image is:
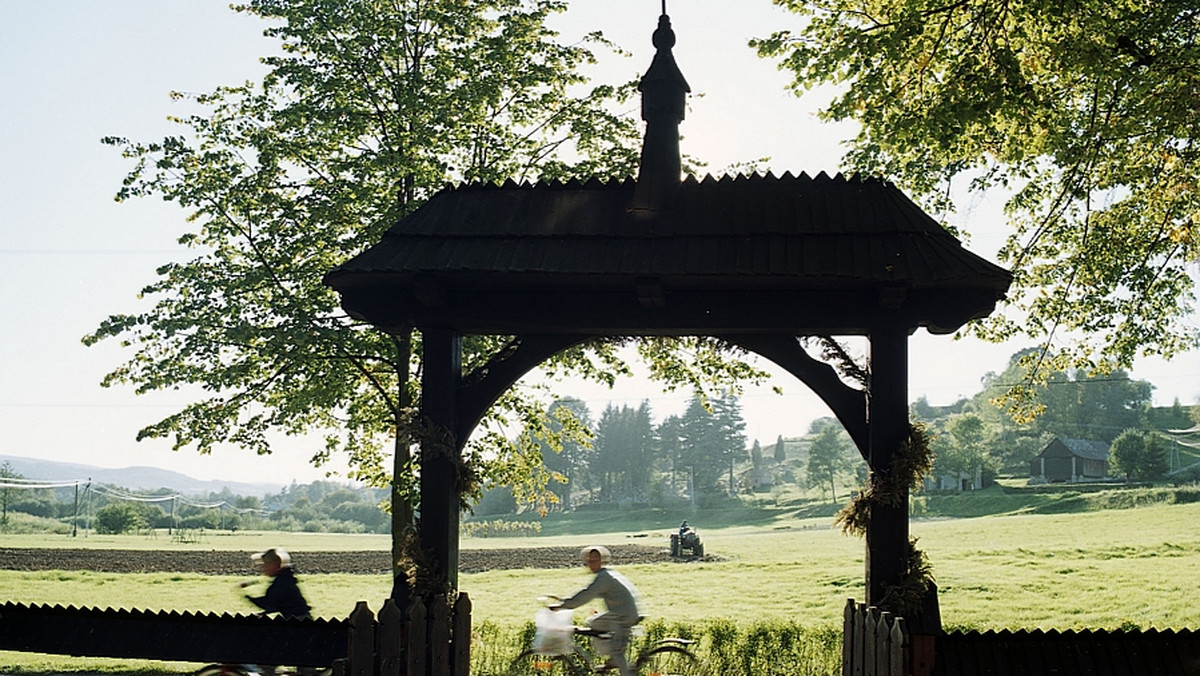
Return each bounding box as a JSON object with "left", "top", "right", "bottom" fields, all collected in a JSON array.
[{"left": 325, "top": 14, "right": 1012, "bottom": 604}]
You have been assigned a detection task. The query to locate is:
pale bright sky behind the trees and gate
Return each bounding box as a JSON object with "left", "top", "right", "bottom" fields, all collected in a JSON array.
[{"left": 0, "top": 0, "right": 1200, "bottom": 483}]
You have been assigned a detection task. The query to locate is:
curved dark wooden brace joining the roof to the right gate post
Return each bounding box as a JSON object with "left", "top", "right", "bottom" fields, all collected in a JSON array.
[{"left": 720, "top": 334, "right": 870, "bottom": 460}]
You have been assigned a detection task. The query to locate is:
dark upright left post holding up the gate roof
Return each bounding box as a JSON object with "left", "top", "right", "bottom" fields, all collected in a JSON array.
[{"left": 419, "top": 329, "right": 463, "bottom": 588}]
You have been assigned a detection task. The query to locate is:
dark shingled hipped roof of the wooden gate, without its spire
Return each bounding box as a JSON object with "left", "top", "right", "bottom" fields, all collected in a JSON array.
[{"left": 326, "top": 173, "right": 1012, "bottom": 335}]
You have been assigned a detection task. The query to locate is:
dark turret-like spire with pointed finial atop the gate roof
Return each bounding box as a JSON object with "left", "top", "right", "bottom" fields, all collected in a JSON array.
[{"left": 632, "top": 5, "right": 691, "bottom": 220}]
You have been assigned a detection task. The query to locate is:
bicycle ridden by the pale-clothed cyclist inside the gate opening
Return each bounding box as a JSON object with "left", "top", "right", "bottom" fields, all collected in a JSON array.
[{"left": 509, "top": 600, "right": 704, "bottom": 676}]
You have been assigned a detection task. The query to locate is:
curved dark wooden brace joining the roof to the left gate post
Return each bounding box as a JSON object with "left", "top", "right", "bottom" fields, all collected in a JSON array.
[{"left": 455, "top": 335, "right": 600, "bottom": 444}]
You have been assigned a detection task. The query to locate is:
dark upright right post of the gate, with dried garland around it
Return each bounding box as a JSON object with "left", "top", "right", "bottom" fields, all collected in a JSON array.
[{"left": 866, "top": 324, "right": 908, "bottom": 605}]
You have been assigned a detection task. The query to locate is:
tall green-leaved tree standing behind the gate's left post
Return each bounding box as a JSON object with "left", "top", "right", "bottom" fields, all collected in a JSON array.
[{"left": 84, "top": 0, "right": 754, "bottom": 583}]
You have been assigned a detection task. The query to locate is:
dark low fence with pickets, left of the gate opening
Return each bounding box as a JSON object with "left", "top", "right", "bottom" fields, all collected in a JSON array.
[{"left": 0, "top": 593, "right": 470, "bottom": 676}]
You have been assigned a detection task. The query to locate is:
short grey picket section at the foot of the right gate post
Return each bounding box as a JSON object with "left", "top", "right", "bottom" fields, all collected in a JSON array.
[{"left": 841, "top": 599, "right": 912, "bottom": 676}]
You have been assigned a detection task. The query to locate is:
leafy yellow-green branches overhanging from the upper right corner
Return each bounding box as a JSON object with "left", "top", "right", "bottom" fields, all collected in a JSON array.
[{"left": 752, "top": 0, "right": 1200, "bottom": 418}]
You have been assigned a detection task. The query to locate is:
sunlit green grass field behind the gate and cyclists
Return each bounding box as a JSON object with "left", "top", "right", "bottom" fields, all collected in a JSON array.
[{"left": 0, "top": 495, "right": 1200, "bottom": 671}]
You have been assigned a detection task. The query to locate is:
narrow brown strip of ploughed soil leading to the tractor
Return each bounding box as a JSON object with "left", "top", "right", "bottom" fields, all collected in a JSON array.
[{"left": 0, "top": 545, "right": 691, "bottom": 575}]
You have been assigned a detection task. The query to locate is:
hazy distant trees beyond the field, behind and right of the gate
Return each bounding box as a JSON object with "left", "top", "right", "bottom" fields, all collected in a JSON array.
[{"left": 476, "top": 351, "right": 1200, "bottom": 515}]
